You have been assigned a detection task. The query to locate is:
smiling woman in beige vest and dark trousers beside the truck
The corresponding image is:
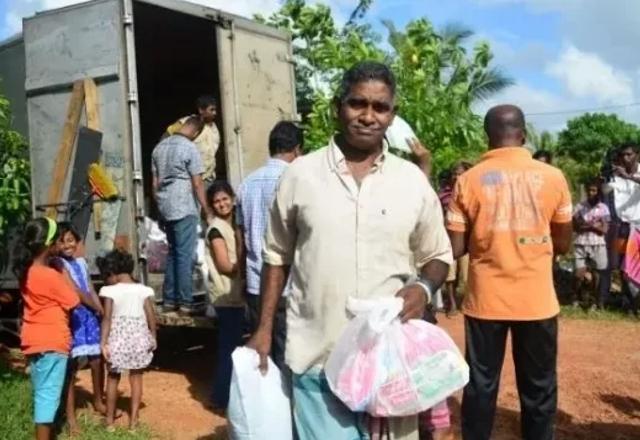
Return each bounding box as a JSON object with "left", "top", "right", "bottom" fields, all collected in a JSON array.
[{"left": 206, "top": 181, "right": 244, "bottom": 411}]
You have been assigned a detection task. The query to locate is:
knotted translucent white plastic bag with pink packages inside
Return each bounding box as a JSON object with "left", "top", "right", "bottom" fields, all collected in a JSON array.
[{"left": 325, "top": 298, "right": 469, "bottom": 417}]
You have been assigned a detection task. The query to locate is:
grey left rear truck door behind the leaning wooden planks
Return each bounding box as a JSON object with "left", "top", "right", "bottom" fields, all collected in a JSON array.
[{"left": 24, "top": 0, "right": 135, "bottom": 262}]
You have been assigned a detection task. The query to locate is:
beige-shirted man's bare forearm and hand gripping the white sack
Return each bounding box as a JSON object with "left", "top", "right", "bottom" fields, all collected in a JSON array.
[{"left": 247, "top": 263, "right": 290, "bottom": 374}]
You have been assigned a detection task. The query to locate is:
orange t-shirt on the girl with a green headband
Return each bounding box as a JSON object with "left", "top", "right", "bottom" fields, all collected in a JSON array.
[{"left": 20, "top": 265, "right": 80, "bottom": 354}]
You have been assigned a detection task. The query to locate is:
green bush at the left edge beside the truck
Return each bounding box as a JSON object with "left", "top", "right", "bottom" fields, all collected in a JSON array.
[{"left": 0, "top": 95, "right": 31, "bottom": 246}]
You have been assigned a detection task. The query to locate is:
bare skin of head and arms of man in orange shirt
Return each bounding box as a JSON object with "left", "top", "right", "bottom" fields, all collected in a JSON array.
[{"left": 449, "top": 105, "right": 573, "bottom": 258}]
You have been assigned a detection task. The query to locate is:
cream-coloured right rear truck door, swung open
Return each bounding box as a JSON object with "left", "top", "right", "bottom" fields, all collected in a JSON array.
[{"left": 217, "top": 15, "right": 297, "bottom": 185}]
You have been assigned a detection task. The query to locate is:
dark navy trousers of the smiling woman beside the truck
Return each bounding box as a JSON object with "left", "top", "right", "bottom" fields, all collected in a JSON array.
[{"left": 211, "top": 307, "right": 245, "bottom": 409}]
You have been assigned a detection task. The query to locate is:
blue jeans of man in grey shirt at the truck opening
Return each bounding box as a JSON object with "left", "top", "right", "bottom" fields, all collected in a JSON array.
[{"left": 162, "top": 215, "right": 198, "bottom": 307}]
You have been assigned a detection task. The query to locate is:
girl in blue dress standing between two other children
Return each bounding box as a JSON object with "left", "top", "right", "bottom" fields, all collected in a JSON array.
[{"left": 54, "top": 222, "right": 106, "bottom": 433}]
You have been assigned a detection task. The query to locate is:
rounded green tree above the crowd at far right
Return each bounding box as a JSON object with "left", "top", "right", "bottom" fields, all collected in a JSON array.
[{"left": 556, "top": 113, "right": 640, "bottom": 189}]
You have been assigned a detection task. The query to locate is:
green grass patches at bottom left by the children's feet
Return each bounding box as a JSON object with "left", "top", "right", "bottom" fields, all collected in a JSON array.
[{"left": 0, "top": 359, "right": 154, "bottom": 440}]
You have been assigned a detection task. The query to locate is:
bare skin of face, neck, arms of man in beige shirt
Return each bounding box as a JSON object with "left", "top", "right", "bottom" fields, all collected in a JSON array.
[{"left": 247, "top": 80, "right": 449, "bottom": 373}]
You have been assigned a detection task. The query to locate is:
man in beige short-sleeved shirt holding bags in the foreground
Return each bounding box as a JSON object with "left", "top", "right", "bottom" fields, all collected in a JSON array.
[{"left": 248, "top": 62, "right": 452, "bottom": 440}]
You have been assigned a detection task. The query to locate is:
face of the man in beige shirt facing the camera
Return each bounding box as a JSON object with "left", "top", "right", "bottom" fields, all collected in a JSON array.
[{"left": 338, "top": 80, "right": 395, "bottom": 151}]
